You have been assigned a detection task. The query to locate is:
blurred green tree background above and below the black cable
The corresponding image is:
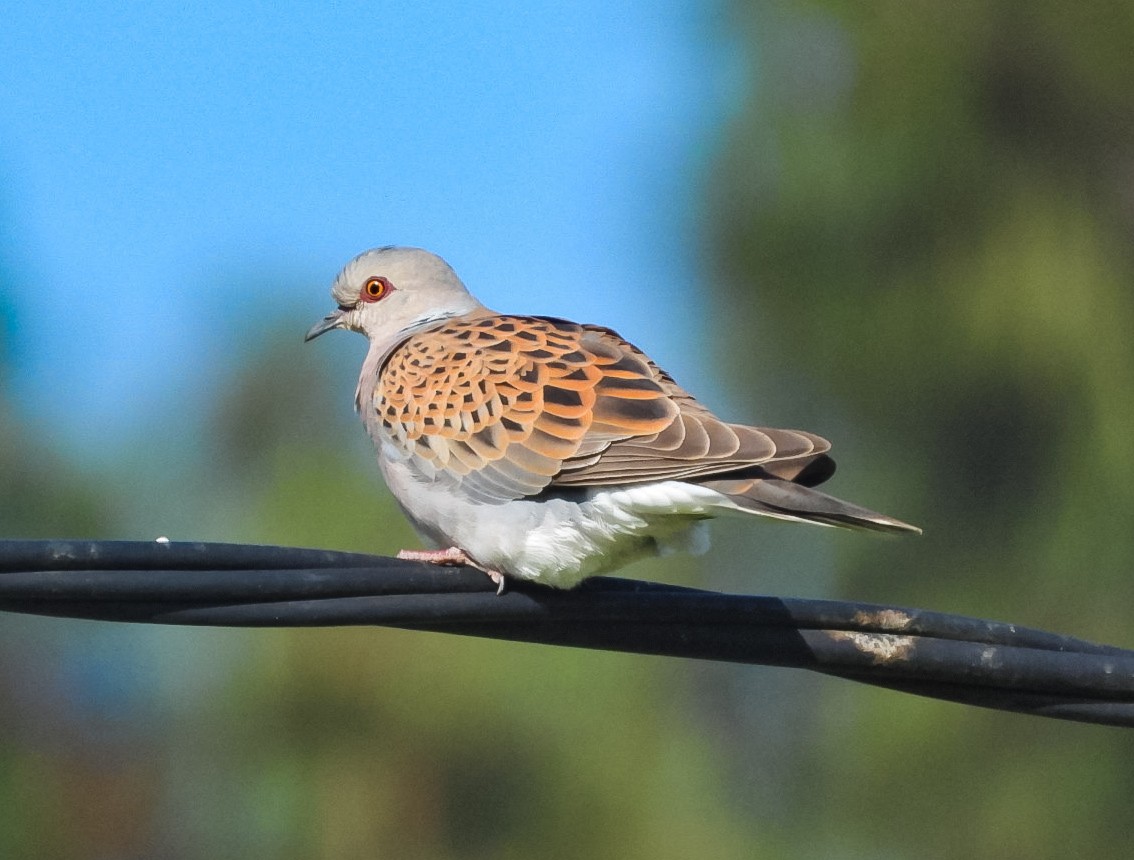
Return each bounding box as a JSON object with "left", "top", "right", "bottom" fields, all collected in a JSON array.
[{"left": 0, "top": 0, "right": 1134, "bottom": 860}]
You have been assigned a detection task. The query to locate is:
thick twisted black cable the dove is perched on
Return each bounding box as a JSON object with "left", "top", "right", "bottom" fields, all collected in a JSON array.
[{"left": 0, "top": 541, "right": 1134, "bottom": 726}]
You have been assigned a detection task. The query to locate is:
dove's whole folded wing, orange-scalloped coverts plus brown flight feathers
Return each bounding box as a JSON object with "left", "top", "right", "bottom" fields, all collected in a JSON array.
[{"left": 374, "top": 315, "right": 826, "bottom": 503}]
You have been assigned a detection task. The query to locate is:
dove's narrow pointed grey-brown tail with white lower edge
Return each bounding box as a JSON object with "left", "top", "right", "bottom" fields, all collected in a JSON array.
[{"left": 701, "top": 478, "right": 921, "bottom": 534}]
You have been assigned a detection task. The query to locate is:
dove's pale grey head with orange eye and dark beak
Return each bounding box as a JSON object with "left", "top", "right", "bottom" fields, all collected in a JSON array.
[{"left": 304, "top": 246, "right": 484, "bottom": 344}]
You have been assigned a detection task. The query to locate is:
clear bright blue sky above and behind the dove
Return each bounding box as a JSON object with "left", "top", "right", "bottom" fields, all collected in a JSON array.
[{"left": 0, "top": 0, "right": 739, "bottom": 447}]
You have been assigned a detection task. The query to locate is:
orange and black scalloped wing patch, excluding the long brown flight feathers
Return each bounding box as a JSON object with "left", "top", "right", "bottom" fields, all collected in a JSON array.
[{"left": 374, "top": 315, "right": 678, "bottom": 501}]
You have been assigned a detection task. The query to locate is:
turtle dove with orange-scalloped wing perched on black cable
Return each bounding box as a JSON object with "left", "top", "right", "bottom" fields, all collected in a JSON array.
[{"left": 305, "top": 245, "right": 921, "bottom": 592}]
